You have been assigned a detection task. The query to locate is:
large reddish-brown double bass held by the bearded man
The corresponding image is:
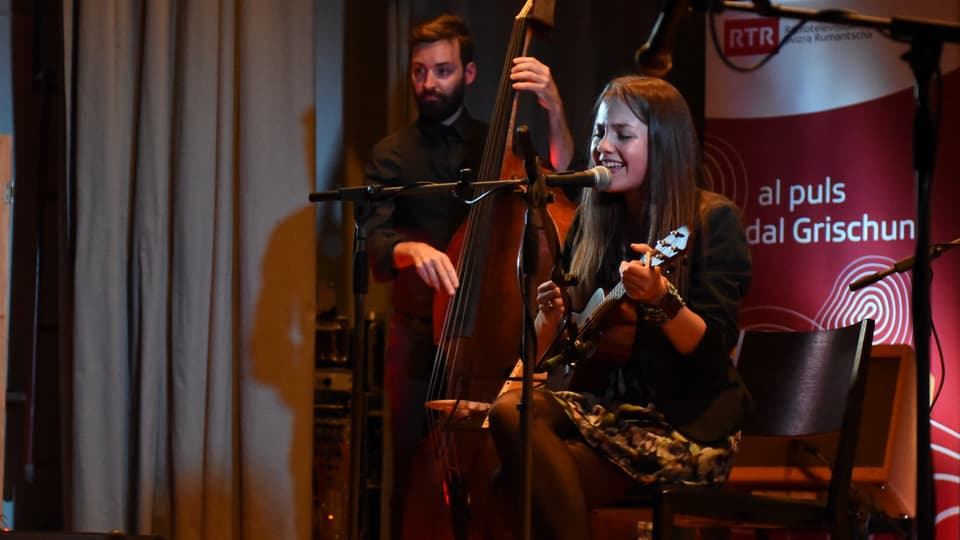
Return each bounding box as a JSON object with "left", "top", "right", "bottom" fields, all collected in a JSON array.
[{"left": 400, "top": 0, "right": 574, "bottom": 540}]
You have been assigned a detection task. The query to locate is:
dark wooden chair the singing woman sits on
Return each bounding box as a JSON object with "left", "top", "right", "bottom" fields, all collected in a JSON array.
[{"left": 600, "top": 319, "right": 874, "bottom": 540}]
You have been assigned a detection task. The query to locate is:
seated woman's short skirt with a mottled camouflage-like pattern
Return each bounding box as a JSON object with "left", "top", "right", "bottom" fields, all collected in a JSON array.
[{"left": 553, "top": 392, "right": 740, "bottom": 484}]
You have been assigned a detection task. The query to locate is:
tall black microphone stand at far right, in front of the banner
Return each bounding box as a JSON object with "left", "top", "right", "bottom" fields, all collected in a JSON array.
[{"left": 692, "top": 0, "right": 960, "bottom": 539}]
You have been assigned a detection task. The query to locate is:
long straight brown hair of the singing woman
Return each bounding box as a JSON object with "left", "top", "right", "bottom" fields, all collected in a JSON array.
[{"left": 570, "top": 75, "right": 703, "bottom": 299}]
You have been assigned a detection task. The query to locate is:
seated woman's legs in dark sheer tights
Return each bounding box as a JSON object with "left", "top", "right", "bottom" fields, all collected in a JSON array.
[{"left": 490, "top": 391, "right": 633, "bottom": 540}]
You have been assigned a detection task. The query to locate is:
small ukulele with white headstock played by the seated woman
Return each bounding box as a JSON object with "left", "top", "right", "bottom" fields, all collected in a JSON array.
[{"left": 538, "top": 225, "right": 690, "bottom": 391}]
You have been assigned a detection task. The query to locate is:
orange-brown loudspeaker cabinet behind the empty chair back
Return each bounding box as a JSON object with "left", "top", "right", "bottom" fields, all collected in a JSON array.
[{"left": 728, "top": 345, "right": 917, "bottom": 517}]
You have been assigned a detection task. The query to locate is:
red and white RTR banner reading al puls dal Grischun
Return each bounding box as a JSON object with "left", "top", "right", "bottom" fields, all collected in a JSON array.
[{"left": 705, "top": 0, "right": 960, "bottom": 540}]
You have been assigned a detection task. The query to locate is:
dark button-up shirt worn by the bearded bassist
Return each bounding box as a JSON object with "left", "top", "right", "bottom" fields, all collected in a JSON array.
[{"left": 364, "top": 109, "right": 487, "bottom": 319}]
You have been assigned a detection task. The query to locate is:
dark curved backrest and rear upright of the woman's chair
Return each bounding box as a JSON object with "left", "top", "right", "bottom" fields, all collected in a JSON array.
[{"left": 734, "top": 319, "right": 874, "bottom": 512}]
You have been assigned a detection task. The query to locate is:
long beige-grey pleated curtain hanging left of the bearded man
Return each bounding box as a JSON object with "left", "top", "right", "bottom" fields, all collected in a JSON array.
[{"left": 64, "top": 0, "right": 316, "bottom": 540}]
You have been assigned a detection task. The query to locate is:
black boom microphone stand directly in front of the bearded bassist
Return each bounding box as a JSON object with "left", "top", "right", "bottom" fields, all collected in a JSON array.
[{"left": 308, "top": 171, "right": 535, "bottom": 540}]
